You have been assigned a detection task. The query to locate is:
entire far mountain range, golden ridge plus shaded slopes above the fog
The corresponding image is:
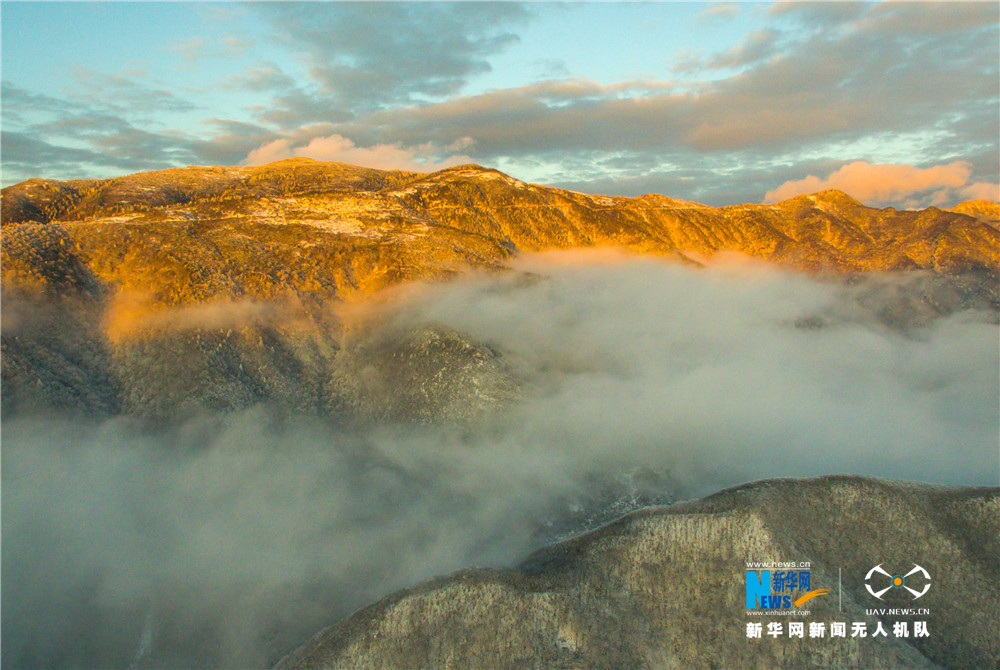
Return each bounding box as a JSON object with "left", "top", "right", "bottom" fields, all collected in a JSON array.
[{"left": 0, "top": 159, "right": 1000, "bottom": 419}]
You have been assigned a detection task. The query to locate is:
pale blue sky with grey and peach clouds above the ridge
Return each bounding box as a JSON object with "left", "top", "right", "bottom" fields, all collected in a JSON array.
[{"left": 0, "top": 2, "right": 1000, "bottom": 207}]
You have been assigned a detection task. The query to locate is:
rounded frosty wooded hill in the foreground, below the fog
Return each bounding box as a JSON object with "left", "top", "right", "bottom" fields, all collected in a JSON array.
[{"left": 278, "top": 476, "right": 1000, "bottom": 670}]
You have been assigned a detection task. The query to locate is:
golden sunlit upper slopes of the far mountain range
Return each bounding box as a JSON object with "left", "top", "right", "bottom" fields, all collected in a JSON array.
[{"left": 2, "top": 159, "right": 1000, "bottom": 305}]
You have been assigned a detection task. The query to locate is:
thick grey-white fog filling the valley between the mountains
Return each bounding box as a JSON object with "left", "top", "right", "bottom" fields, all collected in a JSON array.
[{"left": 2, "top": 255, "right": 1000, "bottom": 668}]
